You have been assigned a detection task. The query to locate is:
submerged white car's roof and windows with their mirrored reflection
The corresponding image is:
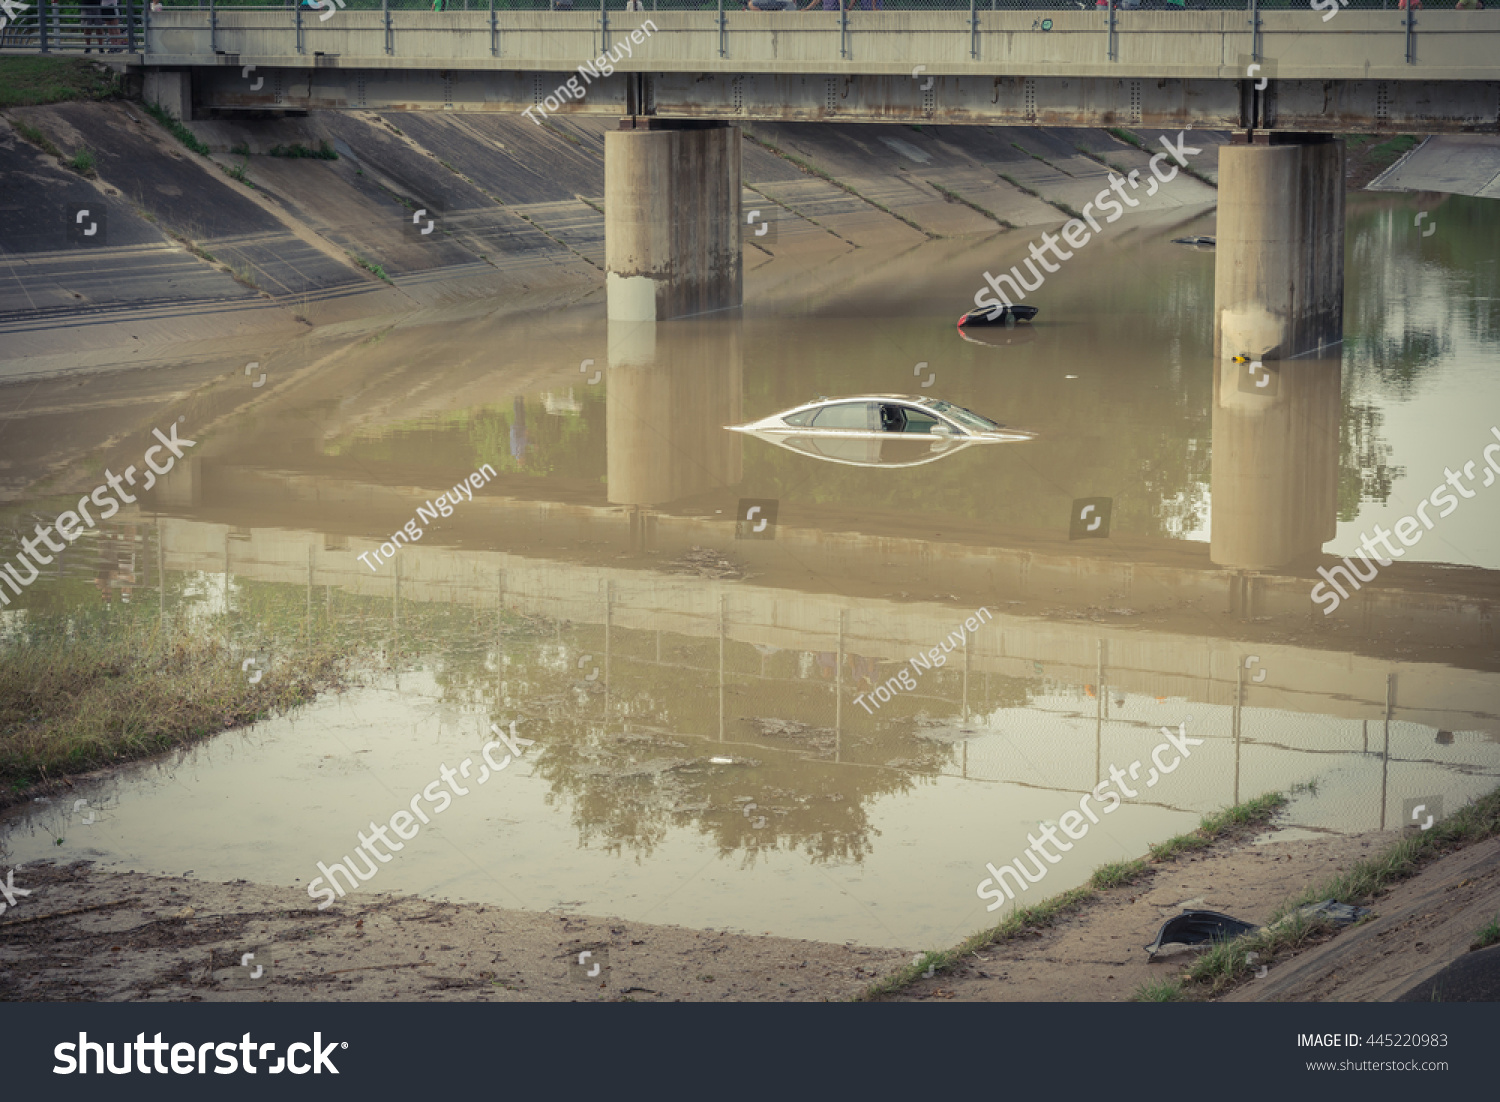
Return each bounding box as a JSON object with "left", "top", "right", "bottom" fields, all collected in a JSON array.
[{"left": 725, "top": 394, "right": 1037, "bottom": 466}]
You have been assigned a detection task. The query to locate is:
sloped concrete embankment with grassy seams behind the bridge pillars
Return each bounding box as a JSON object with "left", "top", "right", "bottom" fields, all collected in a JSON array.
[{"left": 0, "top": 103, "right": 1214, "bottom": 373}]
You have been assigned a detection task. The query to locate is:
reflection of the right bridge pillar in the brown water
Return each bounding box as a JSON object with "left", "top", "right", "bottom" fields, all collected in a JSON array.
[{"left": 1209, "top": 357, "right": 1341, "bottom": 570}]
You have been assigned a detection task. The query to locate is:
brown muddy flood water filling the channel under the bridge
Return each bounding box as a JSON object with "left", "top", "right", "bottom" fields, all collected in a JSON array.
[{"left": 0, "top": 193, "right": 1500, "bottom": 946}]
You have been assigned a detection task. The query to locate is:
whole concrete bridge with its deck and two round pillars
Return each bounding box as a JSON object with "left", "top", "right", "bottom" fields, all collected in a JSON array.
[{"left": 14, "top": 7, "right": 1500, "bottom": 340}]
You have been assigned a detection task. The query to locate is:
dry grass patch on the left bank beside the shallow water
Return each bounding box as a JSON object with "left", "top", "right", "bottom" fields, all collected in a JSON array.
[{"left": 0, "top": 613, "right": 348, "bottom": 804}]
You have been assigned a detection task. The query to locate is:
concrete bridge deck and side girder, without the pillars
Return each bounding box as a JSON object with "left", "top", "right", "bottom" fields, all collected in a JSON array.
[{"left": 105, "top": 11, "right": 1500, "bottom": 133}]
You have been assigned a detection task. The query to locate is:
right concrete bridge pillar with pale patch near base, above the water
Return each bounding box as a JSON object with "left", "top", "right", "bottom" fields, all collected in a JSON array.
[{"left": 1214, "top": 133, "right": 1344, "bottom": 360}]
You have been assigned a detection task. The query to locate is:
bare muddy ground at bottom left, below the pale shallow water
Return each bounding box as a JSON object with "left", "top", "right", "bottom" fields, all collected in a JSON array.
[{"left": 0, "top": 862, "right": 912, "bottom": 1002}]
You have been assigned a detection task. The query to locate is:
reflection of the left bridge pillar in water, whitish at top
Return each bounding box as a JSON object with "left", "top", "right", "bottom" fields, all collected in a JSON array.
[{"left": 605, "top": 316, "right": 744, "bottom": 505}]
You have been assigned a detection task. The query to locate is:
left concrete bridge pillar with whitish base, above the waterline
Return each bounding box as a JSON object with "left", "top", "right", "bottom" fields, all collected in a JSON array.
[{"left": 605, "top": 121, "right": 744, "bottom": 321}]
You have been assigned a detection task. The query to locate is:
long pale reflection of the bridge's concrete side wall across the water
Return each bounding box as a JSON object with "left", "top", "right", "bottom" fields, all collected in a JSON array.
[{"left": 149, "top": 514, "right": 1500, "bottom": 733}]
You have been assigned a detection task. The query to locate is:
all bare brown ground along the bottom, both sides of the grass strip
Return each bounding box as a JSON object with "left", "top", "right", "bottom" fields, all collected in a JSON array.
[{"left": 0, "top": 832, "right": 1500, "bottom": 1002}]
